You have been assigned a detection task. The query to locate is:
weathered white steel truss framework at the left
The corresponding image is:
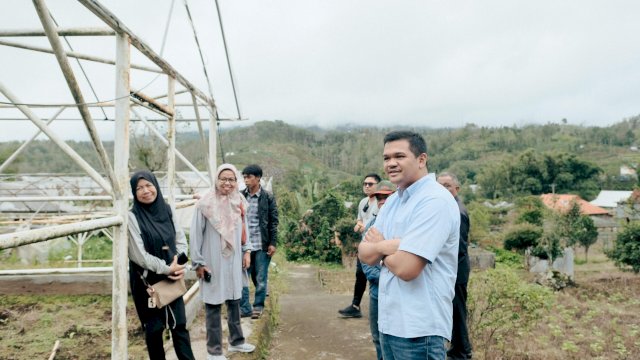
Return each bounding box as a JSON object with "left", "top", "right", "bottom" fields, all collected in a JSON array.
[{"left": 0, "top": 0, "right": 221, "bottom": 359}]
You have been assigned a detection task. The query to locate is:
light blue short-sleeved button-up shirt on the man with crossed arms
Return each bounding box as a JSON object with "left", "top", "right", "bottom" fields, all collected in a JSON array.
[{"left": 374, "top": 174, "right": 460, "bottom": 340}]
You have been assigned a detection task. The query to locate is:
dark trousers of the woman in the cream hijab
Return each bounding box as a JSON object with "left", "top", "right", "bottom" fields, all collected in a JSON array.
[{"left": 206, "top": 299, "right": 244, "bottom": 359}]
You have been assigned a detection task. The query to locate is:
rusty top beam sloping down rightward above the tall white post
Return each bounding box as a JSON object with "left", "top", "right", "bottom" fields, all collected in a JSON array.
[{"left": 78, "top": 0, "right": 215, "bottom": 106}]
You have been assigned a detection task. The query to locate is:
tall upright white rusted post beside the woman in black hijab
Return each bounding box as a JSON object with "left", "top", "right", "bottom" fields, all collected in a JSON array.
[{"left": 111, "top": 33, "right": 131, "bottom": 360}]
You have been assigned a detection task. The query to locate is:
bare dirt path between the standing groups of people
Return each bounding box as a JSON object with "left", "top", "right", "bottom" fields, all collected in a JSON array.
[{"left": 269, "top": 265, "right": 376, "bottom": 360}]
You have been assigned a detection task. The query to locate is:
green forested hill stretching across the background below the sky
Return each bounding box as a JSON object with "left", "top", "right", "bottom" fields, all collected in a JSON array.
[{"left": 0, "top": 116, "right": 640, "bottom": 198}]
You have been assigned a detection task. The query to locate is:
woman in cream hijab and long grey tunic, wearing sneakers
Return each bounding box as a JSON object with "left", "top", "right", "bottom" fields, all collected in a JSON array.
[{"left": 190, "top": 164, "right": 255, "bottom": 360}]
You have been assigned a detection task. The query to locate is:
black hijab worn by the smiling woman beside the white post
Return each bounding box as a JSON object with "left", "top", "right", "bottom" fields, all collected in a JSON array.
[{"left": 129, "top": 170, "right": 177, "bottom": 264}]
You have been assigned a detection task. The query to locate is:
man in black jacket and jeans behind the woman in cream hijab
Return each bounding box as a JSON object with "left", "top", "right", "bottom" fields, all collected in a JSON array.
[{"left": 241, "top": 164, "right": 278, "bottom": 319}]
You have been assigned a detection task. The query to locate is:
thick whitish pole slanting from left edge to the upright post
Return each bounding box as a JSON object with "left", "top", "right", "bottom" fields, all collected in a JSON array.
[{"left": 0, "top": 216, "right": 126, "bottom": 249}]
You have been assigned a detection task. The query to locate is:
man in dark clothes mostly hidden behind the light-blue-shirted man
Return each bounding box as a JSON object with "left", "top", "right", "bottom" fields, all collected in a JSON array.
[{"left": 438, "top": 172, "right": 472, "bottom": 359}]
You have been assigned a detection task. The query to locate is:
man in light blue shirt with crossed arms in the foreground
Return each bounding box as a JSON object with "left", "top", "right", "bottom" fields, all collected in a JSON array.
[{"left": 358, "top": 131, "right": 460, "bottom": 360}]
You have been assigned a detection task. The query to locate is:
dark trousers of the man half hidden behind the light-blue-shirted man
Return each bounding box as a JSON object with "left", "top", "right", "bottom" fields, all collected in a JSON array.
[{"left": 447, "top": 284, "right": 471, "bottom": 359}]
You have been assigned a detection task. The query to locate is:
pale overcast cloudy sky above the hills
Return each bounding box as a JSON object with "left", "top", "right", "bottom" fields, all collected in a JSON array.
[{"left": 0, "top": 0, "right": 640, "bottom": 141}]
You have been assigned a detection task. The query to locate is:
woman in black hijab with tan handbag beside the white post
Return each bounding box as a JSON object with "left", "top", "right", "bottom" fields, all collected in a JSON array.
[{"left": 129, "top": 171, "right": 195, "bottom": 360}]
